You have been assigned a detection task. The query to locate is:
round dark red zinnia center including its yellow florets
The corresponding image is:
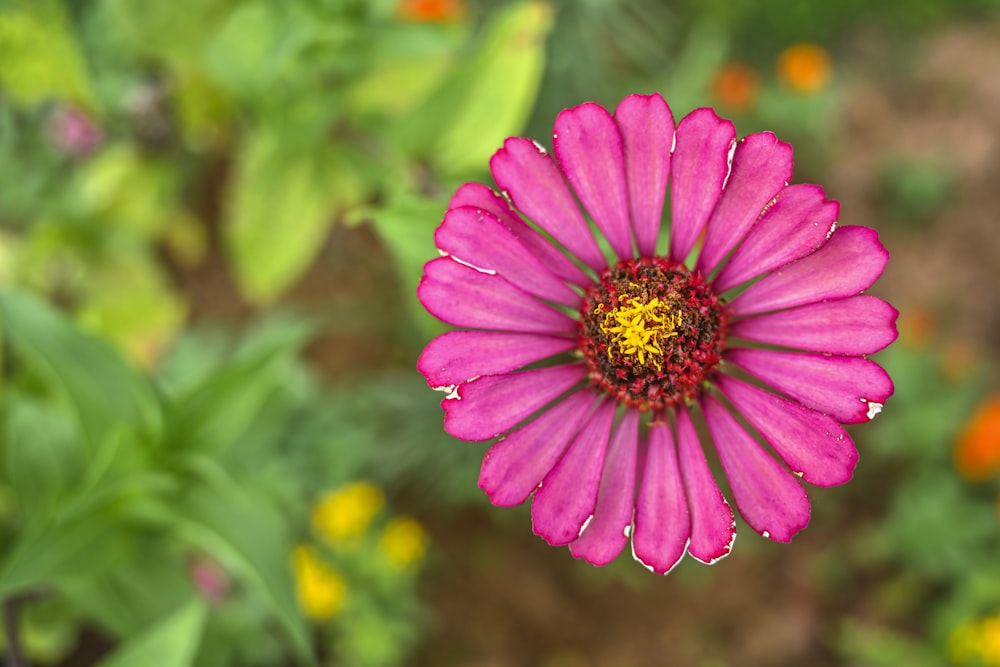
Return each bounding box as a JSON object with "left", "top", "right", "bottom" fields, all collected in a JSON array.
[{"left": 580, "top": 257, "right": 727, "bottom": 411}]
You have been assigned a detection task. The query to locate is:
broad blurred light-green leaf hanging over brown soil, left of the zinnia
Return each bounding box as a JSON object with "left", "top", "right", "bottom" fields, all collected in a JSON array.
[{"left": 224, "top": 127, "right": 356, "bottom": 303}]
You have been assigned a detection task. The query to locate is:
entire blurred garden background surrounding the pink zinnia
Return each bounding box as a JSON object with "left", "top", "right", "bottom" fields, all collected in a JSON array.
[{"left": 0, "top": 0, "right": 1000, "bottom": 667}]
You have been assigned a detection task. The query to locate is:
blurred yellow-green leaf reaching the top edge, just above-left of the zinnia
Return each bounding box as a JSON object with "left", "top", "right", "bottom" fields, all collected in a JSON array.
[{"left": 391, "top": 2, "right": 552, "bottom": 173}]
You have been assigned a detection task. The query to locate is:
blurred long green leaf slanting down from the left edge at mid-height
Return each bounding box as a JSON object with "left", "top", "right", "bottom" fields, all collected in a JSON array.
[{"left": 0, "top": 290, "right": 161, "bottom": 451}]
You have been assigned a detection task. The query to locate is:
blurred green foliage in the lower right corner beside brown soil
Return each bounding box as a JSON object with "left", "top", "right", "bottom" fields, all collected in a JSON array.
[{"left": 837, "top": 331, "right": 1000, "bottom": 667}]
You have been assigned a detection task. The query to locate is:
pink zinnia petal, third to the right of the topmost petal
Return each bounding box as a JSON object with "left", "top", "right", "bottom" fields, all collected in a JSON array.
[{"left": 714, "top": 184, "right": 840, "bottom": 293}]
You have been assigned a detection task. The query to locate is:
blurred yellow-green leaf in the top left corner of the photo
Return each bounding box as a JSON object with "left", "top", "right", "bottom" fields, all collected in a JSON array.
[{"left": 0, "top": 0, "right": 93, "bottom": 106}]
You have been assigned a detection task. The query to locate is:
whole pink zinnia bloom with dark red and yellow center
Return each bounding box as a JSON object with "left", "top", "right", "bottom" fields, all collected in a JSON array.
[{"left": 418, "top": 95, "right": 897, "bottom": 573}]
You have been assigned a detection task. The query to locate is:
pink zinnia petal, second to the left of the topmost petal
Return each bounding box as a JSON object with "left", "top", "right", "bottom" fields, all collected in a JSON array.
[{"left": 490, "top": 137, "right": 607, "bottom": 272}]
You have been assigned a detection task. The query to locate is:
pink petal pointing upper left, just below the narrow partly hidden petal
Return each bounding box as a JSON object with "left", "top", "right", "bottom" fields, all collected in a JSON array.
[{"left": 434, "top": 206, "right": 580, "bottom": 308}]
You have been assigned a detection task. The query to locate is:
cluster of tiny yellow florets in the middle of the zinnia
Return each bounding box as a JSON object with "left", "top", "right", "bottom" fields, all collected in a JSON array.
[{"left": 594, "top": 297, "right": 681, "bottom": 370}]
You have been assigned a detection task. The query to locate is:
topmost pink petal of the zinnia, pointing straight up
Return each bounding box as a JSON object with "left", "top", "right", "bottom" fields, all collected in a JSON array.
[{"left": 615, "top": 93, "right": 674, "bottom": 257}]
